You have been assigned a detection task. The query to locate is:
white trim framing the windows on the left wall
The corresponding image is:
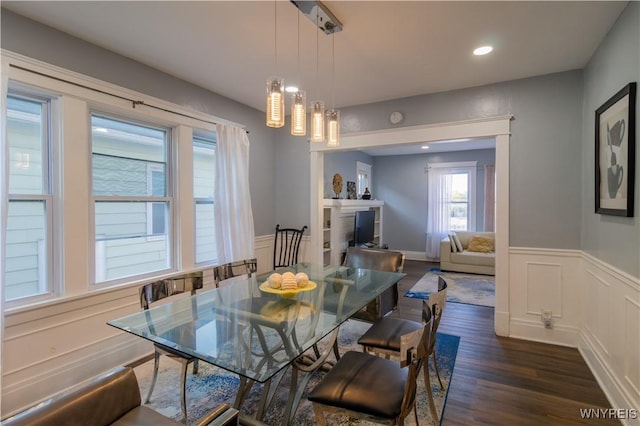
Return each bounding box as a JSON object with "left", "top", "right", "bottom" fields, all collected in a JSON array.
[{"left": 0, "top": 49, "right": 245, "bottom": 313}]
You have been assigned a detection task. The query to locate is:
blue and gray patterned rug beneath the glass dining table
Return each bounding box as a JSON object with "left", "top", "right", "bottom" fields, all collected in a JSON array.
[{"left": 134, "top": 320, "right": 460, "bottom": 426}]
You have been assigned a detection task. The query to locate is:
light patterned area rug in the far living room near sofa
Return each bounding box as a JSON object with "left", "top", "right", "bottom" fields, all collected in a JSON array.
[{"left": 404, "top": 268, "right": 496, "bottom": 306}]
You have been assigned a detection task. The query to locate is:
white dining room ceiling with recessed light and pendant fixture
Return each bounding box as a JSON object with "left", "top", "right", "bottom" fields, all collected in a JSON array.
[{"left": 2, "top": 1, "right": 627, "bottom": 155}]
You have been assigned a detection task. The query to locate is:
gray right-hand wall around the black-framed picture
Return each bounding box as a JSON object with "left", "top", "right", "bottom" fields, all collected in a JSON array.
[{"left": 582, "top": 2, "right": 640, "bottom": 277}]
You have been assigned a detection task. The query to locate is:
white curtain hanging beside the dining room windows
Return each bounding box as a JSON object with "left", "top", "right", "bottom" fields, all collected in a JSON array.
[{"left": 213, "top": 124, "right": 255, "bottom": 264}]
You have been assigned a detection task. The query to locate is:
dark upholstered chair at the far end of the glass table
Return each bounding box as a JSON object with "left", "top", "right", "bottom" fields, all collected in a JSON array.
[{"left": 343, "top": 247, "right": 405, "bottom": 322}]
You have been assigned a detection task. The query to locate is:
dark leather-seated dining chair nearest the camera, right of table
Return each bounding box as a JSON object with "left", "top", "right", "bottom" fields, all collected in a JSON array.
[{"left": 308, "top": 311, "right": 433, "bottom": 426}]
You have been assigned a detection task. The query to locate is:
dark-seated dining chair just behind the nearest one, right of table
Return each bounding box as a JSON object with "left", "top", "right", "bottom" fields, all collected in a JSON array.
[{"left": 358, "top": 277, "right": 447, "bottom": 423}]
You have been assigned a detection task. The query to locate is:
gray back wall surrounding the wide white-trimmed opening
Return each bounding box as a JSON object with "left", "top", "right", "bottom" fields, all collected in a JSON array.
[{"left": 276, "top": 70, "right": 582, "bottom": 249}]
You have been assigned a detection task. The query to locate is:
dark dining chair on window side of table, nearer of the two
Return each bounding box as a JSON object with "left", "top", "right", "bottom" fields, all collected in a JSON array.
[{"left": 140, "top": 272, "right": 203, "bottom": 422}]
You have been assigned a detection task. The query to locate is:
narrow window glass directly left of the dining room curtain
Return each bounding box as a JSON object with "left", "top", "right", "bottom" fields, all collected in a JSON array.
[{"left": 193, "top": 132, "right": 217, "bottom": 263}]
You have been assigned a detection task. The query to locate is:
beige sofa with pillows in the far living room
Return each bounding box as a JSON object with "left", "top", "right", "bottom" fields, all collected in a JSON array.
[{"left": 440, "top": 231, "right": 496, "bottom": 275}]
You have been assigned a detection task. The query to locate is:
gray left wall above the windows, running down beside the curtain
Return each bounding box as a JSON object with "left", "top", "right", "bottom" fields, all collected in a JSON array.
[{"left": 1, "top": 9, "right": 278, "bottom": 235}]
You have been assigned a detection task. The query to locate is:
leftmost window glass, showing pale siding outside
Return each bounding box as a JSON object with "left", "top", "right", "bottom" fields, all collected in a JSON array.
[{"left": 4, "top": 92, "right": 52, "bottom": 301}]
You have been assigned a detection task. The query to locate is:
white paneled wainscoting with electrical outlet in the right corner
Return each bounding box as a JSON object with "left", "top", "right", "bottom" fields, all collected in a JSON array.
[{"left": 509, "top": 247, "right": 640, "bottom": 425}]
